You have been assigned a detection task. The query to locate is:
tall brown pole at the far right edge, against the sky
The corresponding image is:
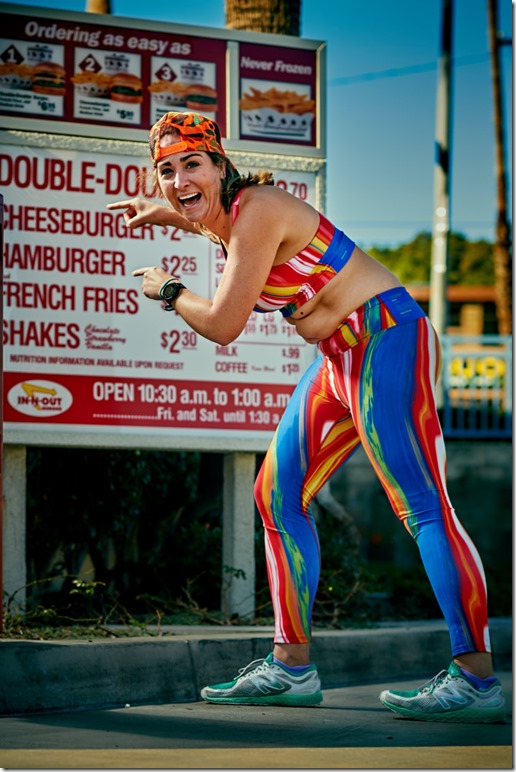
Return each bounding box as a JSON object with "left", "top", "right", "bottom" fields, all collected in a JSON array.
[{"left": 488, "top": 0, "right": 512, "bottom": 335}]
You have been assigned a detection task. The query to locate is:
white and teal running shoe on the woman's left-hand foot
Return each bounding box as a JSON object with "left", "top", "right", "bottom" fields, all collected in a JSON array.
[{"left": 201, "top": 653, "right": 323, "bottom": 707}]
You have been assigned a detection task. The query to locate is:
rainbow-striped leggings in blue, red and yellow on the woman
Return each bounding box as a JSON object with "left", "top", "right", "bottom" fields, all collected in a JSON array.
[{"left": 255, "top": 288, "right": 490, "bottom": 656}]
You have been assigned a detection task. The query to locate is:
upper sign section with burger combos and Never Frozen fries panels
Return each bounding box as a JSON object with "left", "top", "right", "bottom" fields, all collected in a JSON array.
[{"left": 0, "top": 4, "right": 324, "bottom": 156}]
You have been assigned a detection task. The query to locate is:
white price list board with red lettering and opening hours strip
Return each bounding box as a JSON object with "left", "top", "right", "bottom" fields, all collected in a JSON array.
[{"left": 0, "top": 145, "right": 315, "bottom": 437}]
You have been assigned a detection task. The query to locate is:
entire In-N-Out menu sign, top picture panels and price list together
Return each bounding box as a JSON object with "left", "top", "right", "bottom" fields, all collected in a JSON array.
[{"left": 0, "top": 4, "right": 324, "bottom": 449}]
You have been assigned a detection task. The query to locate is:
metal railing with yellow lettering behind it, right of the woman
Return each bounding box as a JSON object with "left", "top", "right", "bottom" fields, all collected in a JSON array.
[{"left": 441, "top": 335, "right": 512, "bottom": 439}]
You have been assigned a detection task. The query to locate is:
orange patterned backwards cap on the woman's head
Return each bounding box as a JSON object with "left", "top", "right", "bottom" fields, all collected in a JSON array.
[{"left": 149, "top": 112, "right": 226, "bottom": 166}]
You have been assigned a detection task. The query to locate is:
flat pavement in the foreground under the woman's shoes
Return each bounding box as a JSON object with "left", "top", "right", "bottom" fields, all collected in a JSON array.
[{"left": 0, "top": 672, "right": 513, "bottom": 770}]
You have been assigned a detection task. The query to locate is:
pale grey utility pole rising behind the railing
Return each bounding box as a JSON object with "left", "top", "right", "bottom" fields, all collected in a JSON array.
[{"left": 429, "top": 0, "right": 453, "bottom": 335}]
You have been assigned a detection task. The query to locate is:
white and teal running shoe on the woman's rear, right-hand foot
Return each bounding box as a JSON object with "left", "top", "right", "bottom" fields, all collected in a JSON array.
[{"left": 380, "top": 662, "right": 505, "bottom": 724}]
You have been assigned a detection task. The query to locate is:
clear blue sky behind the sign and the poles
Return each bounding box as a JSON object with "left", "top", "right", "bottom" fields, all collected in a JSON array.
[{"left": 8, "top": 0, "right": 513, "bottom": 247}]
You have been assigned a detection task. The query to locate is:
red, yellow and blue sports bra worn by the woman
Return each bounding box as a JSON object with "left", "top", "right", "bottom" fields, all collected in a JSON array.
[{"left": 222, "top": 191, "right": 355, "bottom": 317}]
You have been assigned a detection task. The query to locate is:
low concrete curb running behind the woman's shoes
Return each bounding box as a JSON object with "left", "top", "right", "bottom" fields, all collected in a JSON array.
[{"left": 0, "top": 618, "right": 512, "bottom": 715}]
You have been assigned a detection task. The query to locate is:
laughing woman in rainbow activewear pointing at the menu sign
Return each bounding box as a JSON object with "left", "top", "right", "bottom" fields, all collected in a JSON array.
[{"left": 109, "top": 112, "right": 504, "bottom": 722}]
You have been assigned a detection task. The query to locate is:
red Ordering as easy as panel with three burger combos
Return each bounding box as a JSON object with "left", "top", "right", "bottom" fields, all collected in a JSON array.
[{"left": 0, "top": 13, "right": 226, "bottom": 136}]
